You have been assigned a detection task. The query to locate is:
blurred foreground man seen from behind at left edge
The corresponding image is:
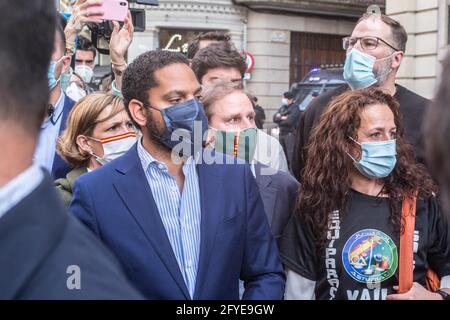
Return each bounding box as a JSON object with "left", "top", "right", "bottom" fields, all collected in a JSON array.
[{"left": 0, "top": 0, "right": 142, "bottom": 300}]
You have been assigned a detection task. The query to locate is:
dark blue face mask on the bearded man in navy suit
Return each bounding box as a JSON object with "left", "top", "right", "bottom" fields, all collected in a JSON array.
[{"left": 150, "top": 98, "right": 208, "bottom": 155}]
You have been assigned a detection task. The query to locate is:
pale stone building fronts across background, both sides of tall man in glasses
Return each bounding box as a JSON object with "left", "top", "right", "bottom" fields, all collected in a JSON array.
[{"left": 61, "top": 0, "right": 450, "bottom": 116}]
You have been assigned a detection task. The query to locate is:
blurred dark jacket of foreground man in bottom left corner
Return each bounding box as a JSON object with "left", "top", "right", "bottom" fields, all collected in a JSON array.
[{"left": 0, "top": 175, "right": 141, "bottom": 300}]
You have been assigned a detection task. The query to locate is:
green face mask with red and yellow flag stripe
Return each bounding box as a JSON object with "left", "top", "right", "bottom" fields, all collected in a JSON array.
[{"left": 210, "top": 127, "right": 257, "bottom": 163}]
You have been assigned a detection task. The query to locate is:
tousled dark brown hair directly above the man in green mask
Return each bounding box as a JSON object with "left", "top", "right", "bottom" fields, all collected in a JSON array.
[{"left": 191, "top": 43, "right": 247, "bottom": 83}]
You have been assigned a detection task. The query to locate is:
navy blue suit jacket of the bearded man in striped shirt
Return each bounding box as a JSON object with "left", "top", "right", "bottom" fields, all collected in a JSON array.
[{"left": 70, "top": 145, "right": 285, "bottom": 300}]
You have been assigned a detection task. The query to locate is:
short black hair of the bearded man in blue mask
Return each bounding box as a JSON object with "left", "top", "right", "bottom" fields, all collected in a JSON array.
[{"left": 122, "top": 49, "right": 189, "bottom": 127}]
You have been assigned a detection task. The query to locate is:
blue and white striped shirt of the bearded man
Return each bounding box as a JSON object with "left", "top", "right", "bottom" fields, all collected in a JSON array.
[{"left": 137, "top": 140, "right": 202, "bottom": 298}]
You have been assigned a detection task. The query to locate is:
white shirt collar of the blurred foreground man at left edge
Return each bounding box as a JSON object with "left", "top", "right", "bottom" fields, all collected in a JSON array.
[{"left": 0, "top": 164, "right": 44, "bottom": 219}]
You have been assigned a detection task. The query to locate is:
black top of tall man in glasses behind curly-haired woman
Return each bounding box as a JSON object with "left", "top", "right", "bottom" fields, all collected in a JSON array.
[{"left": 291, "top": 84, "right": 430, "bottom": 181}]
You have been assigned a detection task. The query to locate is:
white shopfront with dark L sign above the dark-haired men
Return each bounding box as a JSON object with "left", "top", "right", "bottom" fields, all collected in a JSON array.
[{"left": 128, "top": 0, "right": 248, "bottom": 59}]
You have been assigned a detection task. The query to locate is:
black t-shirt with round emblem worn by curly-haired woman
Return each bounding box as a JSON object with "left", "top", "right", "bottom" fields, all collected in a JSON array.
[{"left": 280, "top": 191, "right": 450, "bottom": 300}]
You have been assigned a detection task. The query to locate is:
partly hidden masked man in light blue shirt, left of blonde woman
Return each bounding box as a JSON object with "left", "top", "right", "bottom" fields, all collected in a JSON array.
[{"left": 33, "top": 21, "right": 75, "bottom": 179}]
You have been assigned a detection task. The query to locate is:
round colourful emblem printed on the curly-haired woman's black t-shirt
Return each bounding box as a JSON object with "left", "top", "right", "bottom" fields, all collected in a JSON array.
[{"left": 342, "top": 229, "right": 398, "bottom": 284}]
